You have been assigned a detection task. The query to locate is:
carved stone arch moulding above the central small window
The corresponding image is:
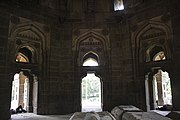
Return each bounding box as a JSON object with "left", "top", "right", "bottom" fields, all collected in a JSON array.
[{"left": 72, "top": 30, "right": 110, "bottom": 66}]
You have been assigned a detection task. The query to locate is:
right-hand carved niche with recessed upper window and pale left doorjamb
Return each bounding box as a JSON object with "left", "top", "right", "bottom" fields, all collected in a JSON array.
[{"left": 131, "top": 16, "right": 172, "bottom": 110}]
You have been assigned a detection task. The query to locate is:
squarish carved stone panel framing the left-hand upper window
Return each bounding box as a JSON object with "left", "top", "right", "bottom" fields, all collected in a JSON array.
[{"left": 8, "top": 15, "right": 50, "bottom": 68}]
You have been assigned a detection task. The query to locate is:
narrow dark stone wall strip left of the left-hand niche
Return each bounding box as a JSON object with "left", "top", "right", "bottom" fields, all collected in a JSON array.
[{"left": 0, "top": 6, "right": 11, "bottom": 119}]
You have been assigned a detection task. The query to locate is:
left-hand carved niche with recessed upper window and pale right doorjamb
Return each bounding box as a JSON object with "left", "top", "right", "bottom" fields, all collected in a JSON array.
[{"left": 7, "top": 16, "right": 50, "bottom": 113}]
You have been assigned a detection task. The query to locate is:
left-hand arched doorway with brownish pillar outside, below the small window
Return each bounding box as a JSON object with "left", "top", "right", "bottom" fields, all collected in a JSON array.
[{"left": 10, "top": 69, "right": 38, "bottom": 113}]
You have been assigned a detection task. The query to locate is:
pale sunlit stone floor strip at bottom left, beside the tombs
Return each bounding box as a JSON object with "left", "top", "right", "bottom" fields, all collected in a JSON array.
[{"left": 11, "top": 113, "right": 72, "bottom": 120}]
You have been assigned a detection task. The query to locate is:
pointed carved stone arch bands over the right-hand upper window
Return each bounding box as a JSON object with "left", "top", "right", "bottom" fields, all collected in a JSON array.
[{"left": 134, "top": 20, "right": 172, "bottom": 62}]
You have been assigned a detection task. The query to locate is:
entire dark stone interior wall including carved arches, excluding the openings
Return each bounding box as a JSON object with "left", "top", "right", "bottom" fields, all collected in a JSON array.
[{"left": 0, "top": 0, "right": 180, "bottom": 120}]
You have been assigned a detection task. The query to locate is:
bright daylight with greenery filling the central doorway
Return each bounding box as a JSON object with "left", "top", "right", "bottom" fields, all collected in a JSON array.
[{"left": 81, "top": 73, "right": 102, "bottom": 112}]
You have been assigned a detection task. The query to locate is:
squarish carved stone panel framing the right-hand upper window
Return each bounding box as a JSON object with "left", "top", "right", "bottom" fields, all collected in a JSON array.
[{"left": 131, "top": 16, "right": 172, "bottom": 67}]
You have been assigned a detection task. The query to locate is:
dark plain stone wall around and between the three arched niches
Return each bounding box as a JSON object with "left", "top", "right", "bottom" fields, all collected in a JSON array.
[{"left": 0, "top": 0, "right": 180, "bottom": 119}]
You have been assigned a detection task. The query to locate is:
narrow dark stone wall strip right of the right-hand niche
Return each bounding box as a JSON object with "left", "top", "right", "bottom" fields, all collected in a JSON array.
[{"left": 170, "top": 1, "right": 180, "bottom": 110}]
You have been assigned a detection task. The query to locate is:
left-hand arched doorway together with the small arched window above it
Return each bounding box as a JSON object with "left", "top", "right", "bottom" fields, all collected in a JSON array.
[{"left": 10, "top": 46, "right": 38, "bottom": 113}]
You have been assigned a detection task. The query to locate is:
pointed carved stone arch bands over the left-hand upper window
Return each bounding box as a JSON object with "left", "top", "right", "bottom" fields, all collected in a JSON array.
[{"left": 9, "top": 21, "right": 47, "bottom": 63}]
